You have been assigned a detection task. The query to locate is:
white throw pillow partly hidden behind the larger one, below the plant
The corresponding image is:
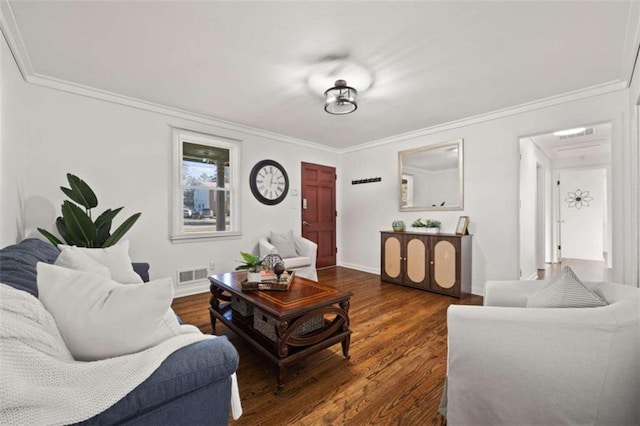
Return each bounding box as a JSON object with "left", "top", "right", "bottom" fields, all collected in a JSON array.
[{"left": 58, "top": 240, "right": 143, "bottom": 284}]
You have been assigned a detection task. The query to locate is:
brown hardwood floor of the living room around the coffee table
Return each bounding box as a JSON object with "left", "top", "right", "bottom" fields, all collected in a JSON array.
[{"left": 173, "top": 267, "right": 482, "bottom": 425}]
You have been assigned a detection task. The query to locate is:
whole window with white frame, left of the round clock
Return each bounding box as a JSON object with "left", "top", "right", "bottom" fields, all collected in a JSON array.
[{"left": 171, "top": 129, "right": 240, "bottom": 241}]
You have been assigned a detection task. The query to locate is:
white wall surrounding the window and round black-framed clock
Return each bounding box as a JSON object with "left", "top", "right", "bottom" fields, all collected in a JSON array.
[{"left": 0, "top": 34, "right": 340, "bottom": 294}]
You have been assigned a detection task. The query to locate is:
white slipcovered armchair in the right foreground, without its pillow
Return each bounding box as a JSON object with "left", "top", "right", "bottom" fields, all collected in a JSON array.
[{"left": 447, "top": 281, "right": 640, "bottom": 426}]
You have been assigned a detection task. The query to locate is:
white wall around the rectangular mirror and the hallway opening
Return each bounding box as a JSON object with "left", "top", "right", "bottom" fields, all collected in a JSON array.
[{"left": 338, "top": 90, "right": 635, "bottom": 294}]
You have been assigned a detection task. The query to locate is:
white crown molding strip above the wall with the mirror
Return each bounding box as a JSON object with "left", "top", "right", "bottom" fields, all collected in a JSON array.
[{"left": 340, "top": 80, "right": 627, "bottom": 154}]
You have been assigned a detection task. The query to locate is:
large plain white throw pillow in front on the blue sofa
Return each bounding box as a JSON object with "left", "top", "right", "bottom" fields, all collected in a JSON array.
[{"left": 37, "top": 262, "right": 181, "bottom": 361}]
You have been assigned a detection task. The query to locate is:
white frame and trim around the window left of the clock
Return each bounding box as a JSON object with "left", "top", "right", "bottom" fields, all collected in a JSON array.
[{"left": 170, "top": 128, "right": 242, "bottom": 243}]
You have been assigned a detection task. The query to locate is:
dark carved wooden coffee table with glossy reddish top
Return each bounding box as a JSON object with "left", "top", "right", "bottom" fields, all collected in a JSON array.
[{"left": 209, "top": 272, "right": 353, "bottom": 393}]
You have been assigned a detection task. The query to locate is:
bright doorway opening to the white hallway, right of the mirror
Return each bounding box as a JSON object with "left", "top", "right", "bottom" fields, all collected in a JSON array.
[{"left": 519, "top": 123, "right": 613, "bottom": 279}]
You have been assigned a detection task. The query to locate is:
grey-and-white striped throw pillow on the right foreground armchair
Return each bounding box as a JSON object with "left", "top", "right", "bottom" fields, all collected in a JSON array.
[{"left": 527, "top": 266, "right": 608, "bottom": 308}]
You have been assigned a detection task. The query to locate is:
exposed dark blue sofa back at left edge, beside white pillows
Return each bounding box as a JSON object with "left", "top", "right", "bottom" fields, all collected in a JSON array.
[{"left": 0, "top": 238, "right": 60, "bottom": 297}]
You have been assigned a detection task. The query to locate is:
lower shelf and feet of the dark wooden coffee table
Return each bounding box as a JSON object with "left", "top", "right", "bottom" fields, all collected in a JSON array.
[{"left": 209, "top": 303, "right": 351, "bottom": 393}]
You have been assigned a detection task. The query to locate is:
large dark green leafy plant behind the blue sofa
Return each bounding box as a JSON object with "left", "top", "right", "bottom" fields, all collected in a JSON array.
[{"left": 38, "top": 173, "right": 142, "bottom": 247}]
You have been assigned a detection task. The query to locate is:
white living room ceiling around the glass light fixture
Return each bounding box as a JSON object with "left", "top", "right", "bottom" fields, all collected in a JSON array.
[{"left": 2, "top": 0, "right": 638, "bottom": 149}]
